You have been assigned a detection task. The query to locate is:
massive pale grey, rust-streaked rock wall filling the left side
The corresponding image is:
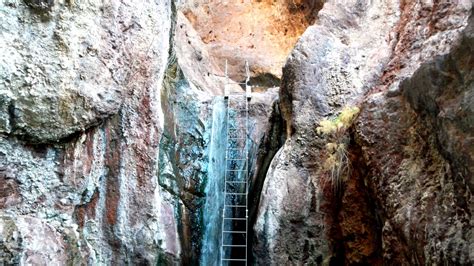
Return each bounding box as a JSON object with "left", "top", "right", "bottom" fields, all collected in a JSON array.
[{"left": 0, "top": 1, "right": 177, "bottom": 264}]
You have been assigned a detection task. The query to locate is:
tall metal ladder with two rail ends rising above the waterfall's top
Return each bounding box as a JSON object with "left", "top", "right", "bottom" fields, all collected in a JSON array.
[{"left": 221, "top": 62, "right": 251, "bottom": 265}]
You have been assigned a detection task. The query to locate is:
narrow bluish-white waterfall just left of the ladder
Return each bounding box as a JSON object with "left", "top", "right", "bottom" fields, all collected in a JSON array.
[{"left": 200, "top": 97, "right": 226, "bottom": 266}]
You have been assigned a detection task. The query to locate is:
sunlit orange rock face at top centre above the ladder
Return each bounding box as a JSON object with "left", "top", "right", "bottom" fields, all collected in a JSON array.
[{"left": 183, "top": 0, "right": 323, "bottom": 82}]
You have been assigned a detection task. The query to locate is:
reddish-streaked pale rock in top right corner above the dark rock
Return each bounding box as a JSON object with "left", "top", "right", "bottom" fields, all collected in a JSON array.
[{"left": 377, "top": 0, "right": 472, "bottom": 89}]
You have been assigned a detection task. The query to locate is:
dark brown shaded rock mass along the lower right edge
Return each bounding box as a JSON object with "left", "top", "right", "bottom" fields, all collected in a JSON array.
[{"left": 348, "top": 12, "right": 474, "bottom": 265}]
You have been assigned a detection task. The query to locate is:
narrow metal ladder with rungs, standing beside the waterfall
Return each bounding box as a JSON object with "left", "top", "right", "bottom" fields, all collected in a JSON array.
[{"left": 220, "top": 60, "right": 251, "bottom": 265}]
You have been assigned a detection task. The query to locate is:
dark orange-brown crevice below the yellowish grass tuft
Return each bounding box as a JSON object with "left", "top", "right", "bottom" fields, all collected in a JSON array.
[{"left": 321, "top": 129, "right": 384, "bottom": 265}]
